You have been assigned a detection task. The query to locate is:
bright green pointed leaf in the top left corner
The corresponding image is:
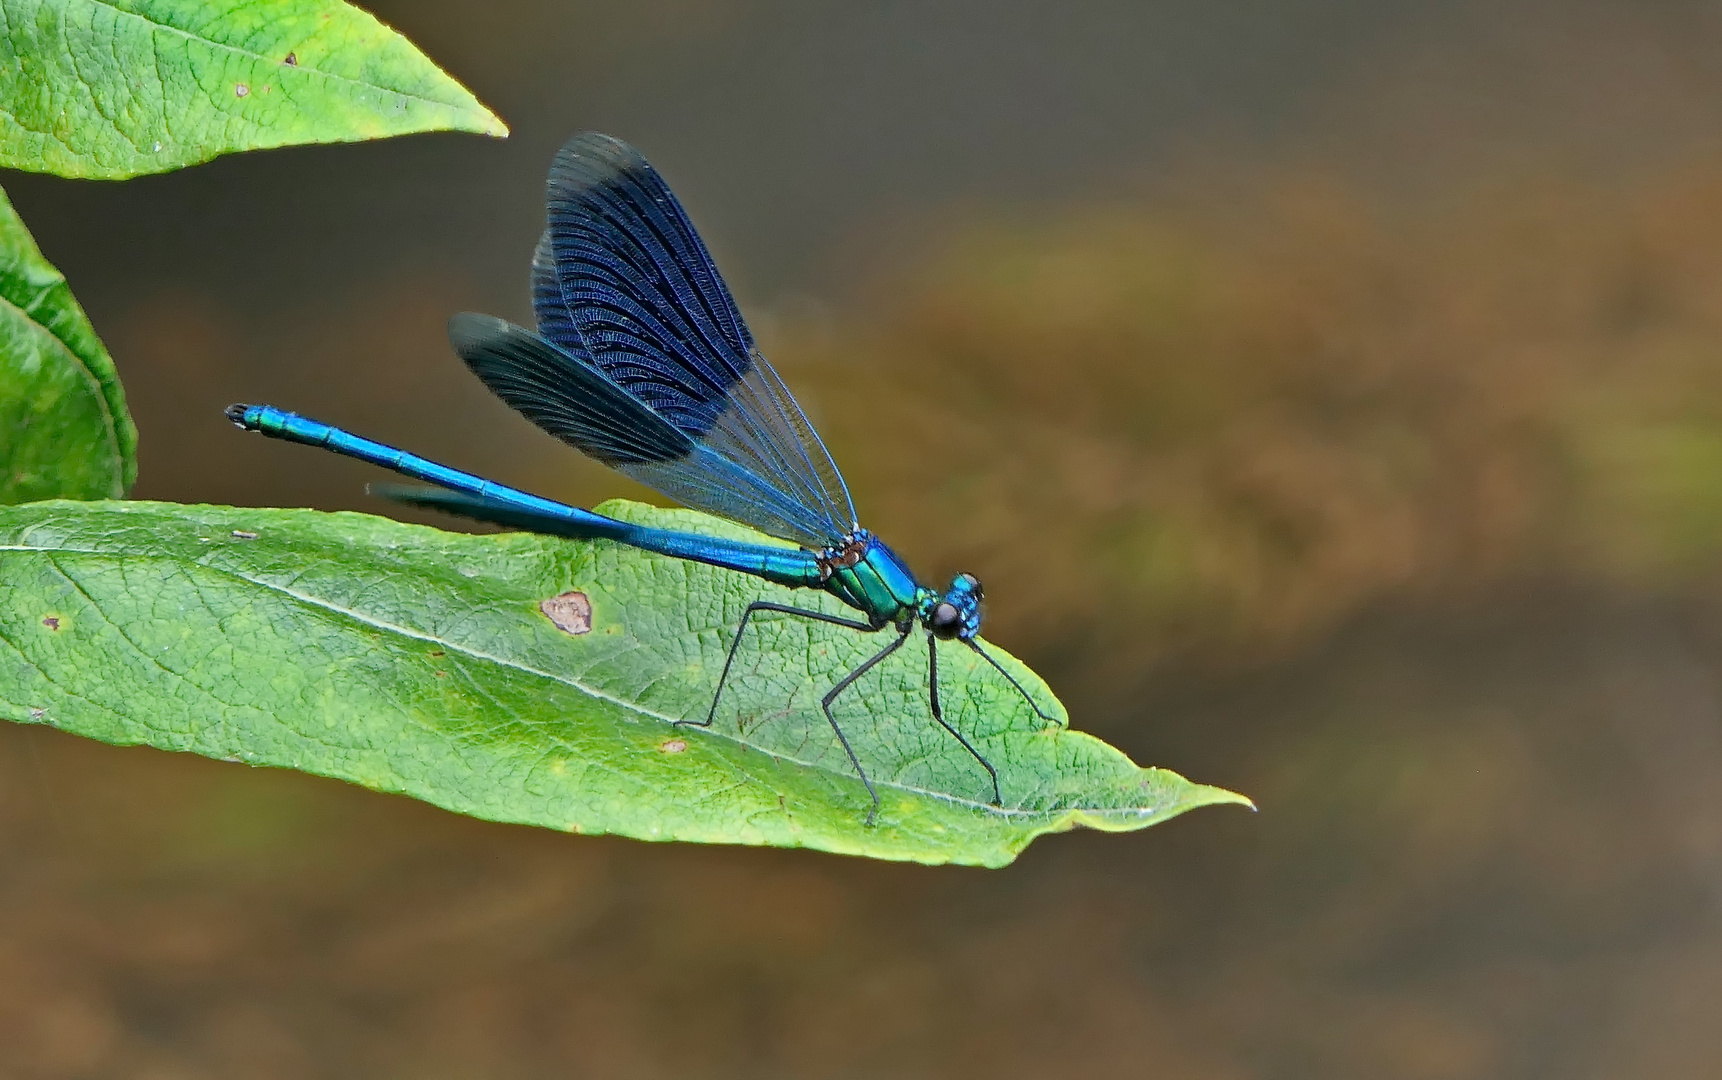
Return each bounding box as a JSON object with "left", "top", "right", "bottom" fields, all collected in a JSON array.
[{"left": 0, "top": 0, "right": 508, "bottom": 179}]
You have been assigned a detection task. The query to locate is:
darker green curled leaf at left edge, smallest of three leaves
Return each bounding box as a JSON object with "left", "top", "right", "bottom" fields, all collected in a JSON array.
[{"left": 0, "top": 182, "right": 138, "bottom": 503}]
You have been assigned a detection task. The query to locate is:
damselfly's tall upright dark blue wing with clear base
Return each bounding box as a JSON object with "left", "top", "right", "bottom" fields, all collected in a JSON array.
[{"left": 522, "top": 133, "right": 856, "bottom": 548}]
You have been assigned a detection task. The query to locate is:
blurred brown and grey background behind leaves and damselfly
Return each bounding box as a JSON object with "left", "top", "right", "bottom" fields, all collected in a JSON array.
[{"left": 10, "top": 0, "right": 1722, "bottom": 1080}]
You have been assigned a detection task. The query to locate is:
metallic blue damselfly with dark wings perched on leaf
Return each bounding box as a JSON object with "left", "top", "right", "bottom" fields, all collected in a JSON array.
[{"left": 227, "top": 133, "right": 1057, "bottom": 823}]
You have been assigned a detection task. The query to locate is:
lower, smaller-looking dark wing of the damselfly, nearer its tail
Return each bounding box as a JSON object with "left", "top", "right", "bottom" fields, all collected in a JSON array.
[{"left": 444, "top": 312, "right": 847, "bottom": 548}]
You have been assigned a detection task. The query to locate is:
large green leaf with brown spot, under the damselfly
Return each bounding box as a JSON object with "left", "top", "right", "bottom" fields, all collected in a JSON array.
[{"left": 0, "top": 503, "right": 1243, "bottom": 866}]
